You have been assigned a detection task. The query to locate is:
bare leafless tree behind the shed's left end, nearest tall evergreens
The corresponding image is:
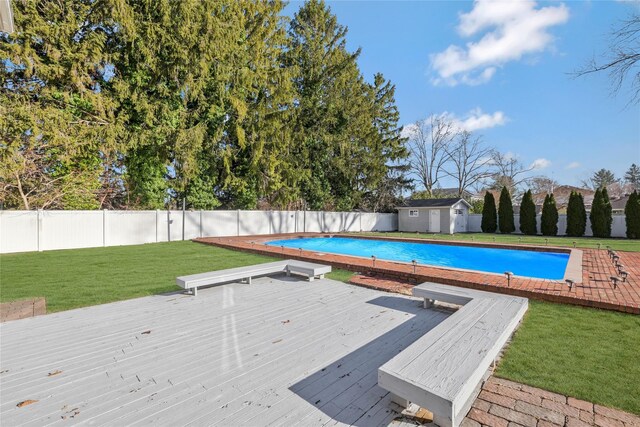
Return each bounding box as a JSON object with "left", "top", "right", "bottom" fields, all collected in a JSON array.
[{"left": 407, "top": 116, "right": 458, "bottom": 196}]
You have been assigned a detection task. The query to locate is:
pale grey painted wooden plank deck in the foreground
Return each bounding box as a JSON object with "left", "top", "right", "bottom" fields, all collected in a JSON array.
[{"left": 0, "top": 276, "right": 449, "bottom": 426}]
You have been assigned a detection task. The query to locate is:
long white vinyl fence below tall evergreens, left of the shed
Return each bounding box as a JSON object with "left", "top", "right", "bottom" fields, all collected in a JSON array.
[{"left": 0, "top": 210, "right": 398, "bottom": 253}]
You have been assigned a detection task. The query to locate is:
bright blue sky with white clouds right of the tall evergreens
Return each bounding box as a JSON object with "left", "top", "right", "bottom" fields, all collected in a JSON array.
[{"left": 285, "top": 1, "right": 640, "bottom": 186}]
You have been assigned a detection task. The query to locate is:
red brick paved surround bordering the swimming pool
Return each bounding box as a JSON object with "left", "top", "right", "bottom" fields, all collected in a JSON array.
[{"left": 194, "top": 233, "right": 640, "bottom": 314}]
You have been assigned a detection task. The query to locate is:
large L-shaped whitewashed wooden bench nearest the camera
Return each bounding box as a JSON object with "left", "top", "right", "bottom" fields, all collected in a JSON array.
[{"left": 378, "top": 283, "right": 528, "bottom": 427}]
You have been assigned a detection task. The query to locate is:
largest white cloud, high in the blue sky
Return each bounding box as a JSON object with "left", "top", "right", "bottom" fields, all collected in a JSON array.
[{"left": 431, "top": 0, "right": 569, "bottom": 86}]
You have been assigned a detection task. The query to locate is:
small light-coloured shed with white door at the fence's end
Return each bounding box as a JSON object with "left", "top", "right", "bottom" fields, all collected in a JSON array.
[{"left": 397, "top": 197, "right": 471, "bottom": 234}]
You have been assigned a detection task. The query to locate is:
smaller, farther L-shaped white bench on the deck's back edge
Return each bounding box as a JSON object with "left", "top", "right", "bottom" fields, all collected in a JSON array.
[{"left": 176, "top": 259, "right": 331, "bottom": 296}]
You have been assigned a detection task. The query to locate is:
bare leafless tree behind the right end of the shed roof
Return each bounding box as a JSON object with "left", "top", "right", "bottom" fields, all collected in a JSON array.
[{"left": 444, "top": 131, "right": 493, "bottom": 196}]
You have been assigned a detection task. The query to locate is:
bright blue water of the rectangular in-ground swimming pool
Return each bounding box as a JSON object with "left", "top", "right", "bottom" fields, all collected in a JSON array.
[{"left": 266, "top": 237, "right": 569, "bottom": 280}]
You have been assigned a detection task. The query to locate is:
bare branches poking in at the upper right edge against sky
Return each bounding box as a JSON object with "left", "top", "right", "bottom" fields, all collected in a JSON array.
[{"left": 575, "top": 13, "right": 640, "bottom": 104}]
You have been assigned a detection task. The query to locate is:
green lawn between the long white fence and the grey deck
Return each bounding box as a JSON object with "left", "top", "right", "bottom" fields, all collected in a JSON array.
[{"left": 0, "top": 242, "right": 352, "bottom": 313}]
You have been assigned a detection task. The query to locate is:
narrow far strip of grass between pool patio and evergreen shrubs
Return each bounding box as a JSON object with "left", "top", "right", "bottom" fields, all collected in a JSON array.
[{"left": 358, "top": 232, "right": 640, "bottom": 252}]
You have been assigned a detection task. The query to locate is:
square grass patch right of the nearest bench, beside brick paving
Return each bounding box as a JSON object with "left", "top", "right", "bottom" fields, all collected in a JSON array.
[{"left": 496, "top": 301, "right": 640, "bottom": 415}]
